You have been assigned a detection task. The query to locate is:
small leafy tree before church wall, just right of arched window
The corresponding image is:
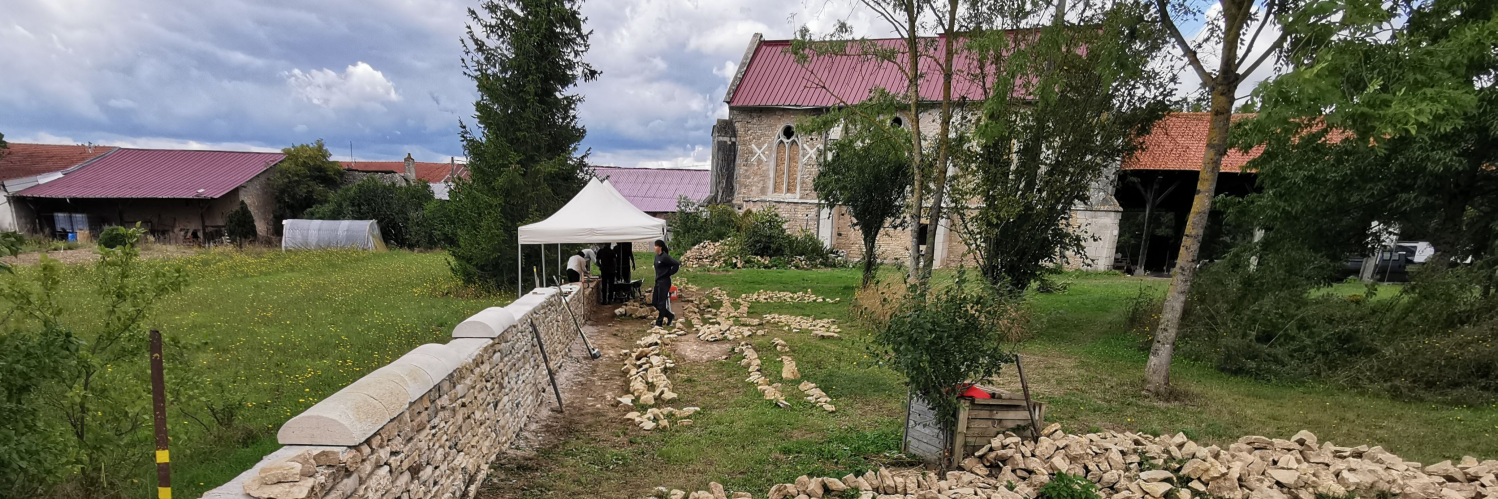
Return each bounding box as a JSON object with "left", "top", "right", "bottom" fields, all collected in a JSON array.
[{"left": 812, "top": 120, "right": 911, "bottom": 286}]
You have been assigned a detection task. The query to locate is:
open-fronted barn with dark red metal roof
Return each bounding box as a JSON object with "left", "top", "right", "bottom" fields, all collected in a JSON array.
[{"left": 10, "top": 148, "right": 283, "bottom": 243}]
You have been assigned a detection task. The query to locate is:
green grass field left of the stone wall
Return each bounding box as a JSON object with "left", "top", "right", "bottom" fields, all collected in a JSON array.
[{"left": 19, "top": 250, "right": 508, "bottom": 498}]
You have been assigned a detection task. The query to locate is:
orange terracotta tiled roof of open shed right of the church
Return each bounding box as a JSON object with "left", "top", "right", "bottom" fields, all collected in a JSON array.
[{"left": 1124, "top": 112, "right": 1263, "bottom": 172}]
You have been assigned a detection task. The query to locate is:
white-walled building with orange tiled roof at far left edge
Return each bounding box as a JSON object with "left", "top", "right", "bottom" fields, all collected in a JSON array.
[{"left": 0, "top": 142, "right": 115, "bottom": 231}]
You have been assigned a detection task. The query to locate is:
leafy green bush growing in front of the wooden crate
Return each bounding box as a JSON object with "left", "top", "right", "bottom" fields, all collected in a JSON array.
[{"left": 873, "top": 270, "right": 1031, "bottom": 424}]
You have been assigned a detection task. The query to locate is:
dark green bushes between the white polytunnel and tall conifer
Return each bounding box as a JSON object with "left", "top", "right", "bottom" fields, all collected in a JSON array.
[{"left": 303, "top": 177, "right": 436, "bottom": 247}]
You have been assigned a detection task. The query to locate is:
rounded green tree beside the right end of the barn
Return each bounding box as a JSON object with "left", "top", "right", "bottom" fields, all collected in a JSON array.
[{"left": 270, "top": 139, "right": 343, "bottom": 224}]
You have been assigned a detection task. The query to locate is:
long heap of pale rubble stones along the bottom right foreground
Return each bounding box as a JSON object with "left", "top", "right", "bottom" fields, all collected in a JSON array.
[{"left": 659, "top": 424, "right": 1498, "bottom": 499}]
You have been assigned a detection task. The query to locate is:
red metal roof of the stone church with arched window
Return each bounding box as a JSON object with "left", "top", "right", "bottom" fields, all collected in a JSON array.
[{"left": 728, "top": 37, "right": 1006, "bottom": 108}]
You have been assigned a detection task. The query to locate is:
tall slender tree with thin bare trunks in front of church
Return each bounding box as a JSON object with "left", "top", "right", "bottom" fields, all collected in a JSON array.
[{"left": 791, "top": 0, "right": 963, "bottom": 289}]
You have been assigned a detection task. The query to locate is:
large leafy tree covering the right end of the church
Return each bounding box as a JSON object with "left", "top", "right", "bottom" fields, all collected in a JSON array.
[{"left": 953, "top": 0, "right": 1174, "bottom": 294}]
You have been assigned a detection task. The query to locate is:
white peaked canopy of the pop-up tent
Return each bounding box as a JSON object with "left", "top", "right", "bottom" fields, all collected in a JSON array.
[{"left": 515, "top": 178, "right": 667, "bottom": 294}]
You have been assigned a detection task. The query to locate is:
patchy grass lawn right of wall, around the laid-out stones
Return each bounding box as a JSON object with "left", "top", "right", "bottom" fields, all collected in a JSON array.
[{"left": 482, "top": 262, "right": 1498, "bottom": 498}]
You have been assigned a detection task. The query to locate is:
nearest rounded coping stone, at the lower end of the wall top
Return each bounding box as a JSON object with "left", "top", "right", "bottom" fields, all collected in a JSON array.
[{"left": 276, "top": 390, "right": 391, "bottom": 447}]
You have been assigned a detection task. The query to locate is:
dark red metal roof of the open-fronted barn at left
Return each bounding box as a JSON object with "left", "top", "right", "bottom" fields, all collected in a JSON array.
[{"left": 16, "top": 148, "right": 285, "bottom": 199}]
